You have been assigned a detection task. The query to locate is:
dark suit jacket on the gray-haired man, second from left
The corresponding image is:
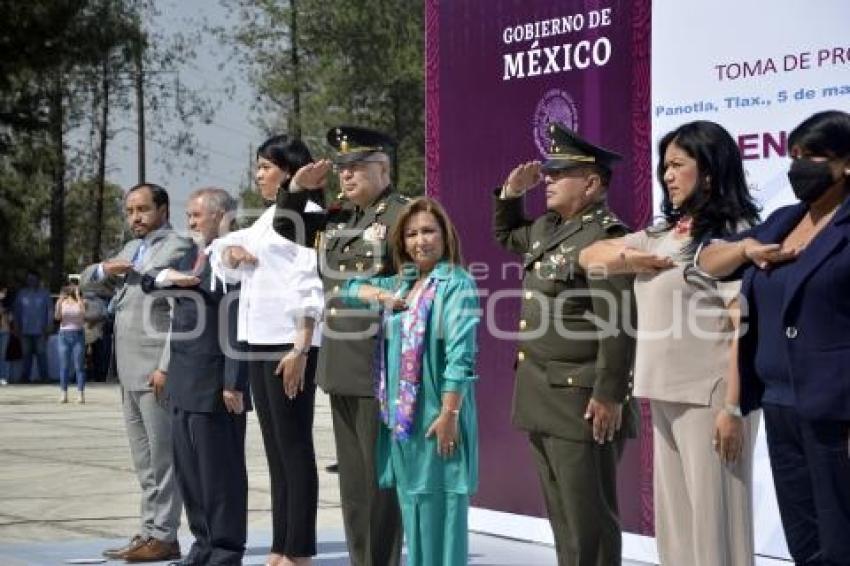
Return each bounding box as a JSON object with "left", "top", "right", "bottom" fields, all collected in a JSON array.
[{"left": 142, "top": 248, "right": 250, "bottom": 413}]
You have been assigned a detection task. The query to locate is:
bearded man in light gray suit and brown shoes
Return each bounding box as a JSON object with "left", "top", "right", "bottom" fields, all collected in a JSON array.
[{"left": 81, "top": 183, "right": 192, "bottom": 562}]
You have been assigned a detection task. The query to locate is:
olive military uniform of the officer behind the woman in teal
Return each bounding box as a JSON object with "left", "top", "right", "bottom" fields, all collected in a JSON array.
[{"left": 278, "top": 184, "right": 408, "bottom": 566}]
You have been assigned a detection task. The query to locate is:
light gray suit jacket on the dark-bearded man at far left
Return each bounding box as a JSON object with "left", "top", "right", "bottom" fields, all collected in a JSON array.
[{"left": 80, "top": 225, "right": 192, "bottom": 391}]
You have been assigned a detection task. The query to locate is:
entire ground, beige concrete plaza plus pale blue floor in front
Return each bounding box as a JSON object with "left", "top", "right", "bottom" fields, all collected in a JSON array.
[{"left": 0, "top": 383, "right": 568, "bottom": 566}]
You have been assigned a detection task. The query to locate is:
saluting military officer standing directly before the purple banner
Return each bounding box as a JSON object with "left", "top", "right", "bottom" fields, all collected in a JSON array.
[{"left": 493, "top": 123, "right": 635, "bottom": 566}]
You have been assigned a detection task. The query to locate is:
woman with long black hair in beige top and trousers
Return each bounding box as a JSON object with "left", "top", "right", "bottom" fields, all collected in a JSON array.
[{"left": 579, "top": 121, "right": 758, "bottom": 566}]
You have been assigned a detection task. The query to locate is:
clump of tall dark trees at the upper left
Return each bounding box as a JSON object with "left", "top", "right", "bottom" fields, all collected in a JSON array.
[{"left": 0, "top": 0, "right": 219, "bottom": 290}]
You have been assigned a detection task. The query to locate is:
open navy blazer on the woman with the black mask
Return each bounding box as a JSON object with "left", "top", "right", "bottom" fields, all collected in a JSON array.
[{"left": 729, "top": 198, "right": 850, "bottom": 420}]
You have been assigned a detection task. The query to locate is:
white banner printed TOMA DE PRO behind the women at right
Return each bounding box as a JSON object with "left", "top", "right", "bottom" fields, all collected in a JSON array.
[{"left": 651, "top": 0, "right": 850, "bottom": 557}]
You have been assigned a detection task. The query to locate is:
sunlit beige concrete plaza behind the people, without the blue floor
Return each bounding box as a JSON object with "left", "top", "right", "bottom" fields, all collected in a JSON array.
[{"left": 0, "top": 383, "right": 342, "bottom": 544}]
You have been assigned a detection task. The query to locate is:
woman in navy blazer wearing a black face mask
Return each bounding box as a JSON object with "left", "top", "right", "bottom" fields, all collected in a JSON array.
[{"left": 698, "top": 111, "right": 850, "bottom": 565}]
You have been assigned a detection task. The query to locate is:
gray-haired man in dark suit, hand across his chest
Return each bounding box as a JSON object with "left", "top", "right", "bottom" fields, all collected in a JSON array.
[{"left": 142, "top": 188, "right": 250, "bottom": 566}]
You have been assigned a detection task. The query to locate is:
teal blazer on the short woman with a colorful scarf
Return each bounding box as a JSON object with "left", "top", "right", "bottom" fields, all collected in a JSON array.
[{"left": 342, "top": 262, "right": 481, "bottom": 495}]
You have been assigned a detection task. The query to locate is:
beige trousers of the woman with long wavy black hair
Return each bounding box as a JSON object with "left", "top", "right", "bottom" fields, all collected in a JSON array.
[{"left": 650, "top": 400, "right": 760, "bottom": 566}]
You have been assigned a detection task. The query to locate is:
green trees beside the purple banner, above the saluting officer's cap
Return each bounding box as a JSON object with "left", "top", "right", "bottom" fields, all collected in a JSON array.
[{"left": 219, "top": 0, "right": 425, "bottom": 194}]
